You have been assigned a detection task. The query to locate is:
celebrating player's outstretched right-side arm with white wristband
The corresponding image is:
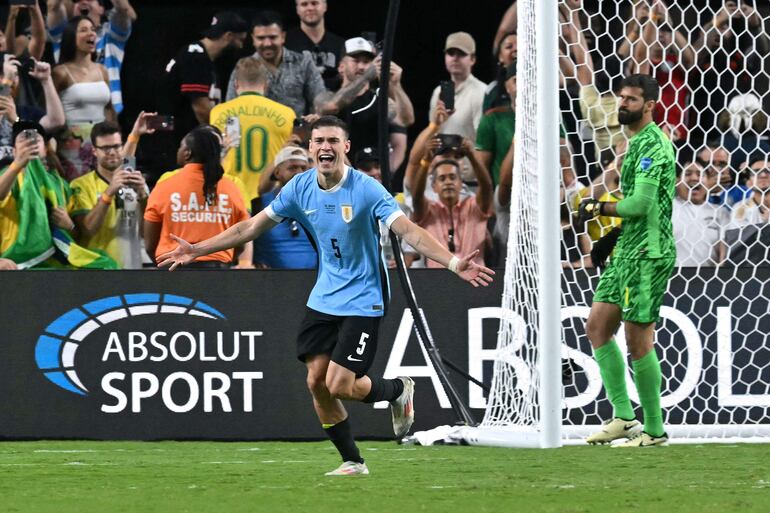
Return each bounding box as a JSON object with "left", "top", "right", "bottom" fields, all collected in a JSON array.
[{"left": 390, "top": 216, "right": 495, "bottom": 287}]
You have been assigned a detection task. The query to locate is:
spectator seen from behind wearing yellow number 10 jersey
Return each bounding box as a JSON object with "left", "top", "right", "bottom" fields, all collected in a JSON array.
[{"left": 211, "top": 57, "right": 295, "bottom": 202}]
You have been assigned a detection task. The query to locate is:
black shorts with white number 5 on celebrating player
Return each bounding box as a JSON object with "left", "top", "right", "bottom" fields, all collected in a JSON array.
[{"left": 297, "top": 308, "right": 382, "bottom": 378}]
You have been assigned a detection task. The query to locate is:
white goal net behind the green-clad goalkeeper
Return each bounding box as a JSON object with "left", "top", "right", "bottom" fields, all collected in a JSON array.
[{"left": 462, "top": 0, "right": 770, "bottom": 446}]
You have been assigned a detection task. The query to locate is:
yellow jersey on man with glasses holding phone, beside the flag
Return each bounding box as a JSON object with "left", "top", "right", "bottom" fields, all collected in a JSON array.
[{"left": 69, "top": 171, "right": 123, "bottom": 262}]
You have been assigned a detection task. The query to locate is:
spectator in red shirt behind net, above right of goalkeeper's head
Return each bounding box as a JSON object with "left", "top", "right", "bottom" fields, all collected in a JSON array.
[{"left": 633, "top": 0, "right": 695, "bottom": 143}]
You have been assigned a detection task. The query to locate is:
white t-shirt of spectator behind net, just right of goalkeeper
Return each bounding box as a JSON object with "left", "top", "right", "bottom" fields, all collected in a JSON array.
[{"left": 671, "top": 197, "right": 728, "bottom": 267}]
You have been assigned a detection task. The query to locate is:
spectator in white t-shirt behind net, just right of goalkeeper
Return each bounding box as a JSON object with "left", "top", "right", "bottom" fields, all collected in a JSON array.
[{"left": 671, "top": 162, "right": 727, "bottom": 267}]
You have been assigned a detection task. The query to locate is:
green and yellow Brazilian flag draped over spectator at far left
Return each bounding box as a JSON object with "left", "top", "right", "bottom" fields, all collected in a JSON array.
[{"left": 0, "top": 159, "right": 119, "bottom": 269}]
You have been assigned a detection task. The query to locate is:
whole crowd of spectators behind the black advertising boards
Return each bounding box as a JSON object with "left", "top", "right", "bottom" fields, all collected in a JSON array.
[{"left": 0, "top": 0, "right": 770, "bottom": 269}]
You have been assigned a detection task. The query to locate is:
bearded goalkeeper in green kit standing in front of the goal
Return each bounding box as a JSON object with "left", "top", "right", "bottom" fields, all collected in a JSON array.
[{"left": 578, "top": 75, "right": 676, "bottom": 447}]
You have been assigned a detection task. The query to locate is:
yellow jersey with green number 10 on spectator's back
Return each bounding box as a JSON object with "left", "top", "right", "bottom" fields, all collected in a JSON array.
[{"left": 210, "top": 93, "right": 295, "bottom": 204}]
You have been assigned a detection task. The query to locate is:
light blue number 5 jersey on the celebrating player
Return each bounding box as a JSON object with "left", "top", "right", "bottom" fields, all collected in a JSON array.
[{"left": 265, "top": 167, "right": 404, "bottom": 317}]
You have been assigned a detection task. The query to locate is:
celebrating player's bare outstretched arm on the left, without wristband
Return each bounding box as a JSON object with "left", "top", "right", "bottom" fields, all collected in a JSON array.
[{"left": 158, "top": 210, "right": 278, "bottom": 271}]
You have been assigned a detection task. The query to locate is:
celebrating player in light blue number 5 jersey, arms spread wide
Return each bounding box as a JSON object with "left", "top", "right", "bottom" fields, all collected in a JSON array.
[{"left": 158, "top": 116, "right": 494, "bottom": 475}]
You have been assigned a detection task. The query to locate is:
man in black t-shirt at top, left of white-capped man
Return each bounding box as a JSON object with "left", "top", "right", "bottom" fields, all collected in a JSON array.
[{"left": 286, "top": 0, "right": 345, "bottom": 89}]
